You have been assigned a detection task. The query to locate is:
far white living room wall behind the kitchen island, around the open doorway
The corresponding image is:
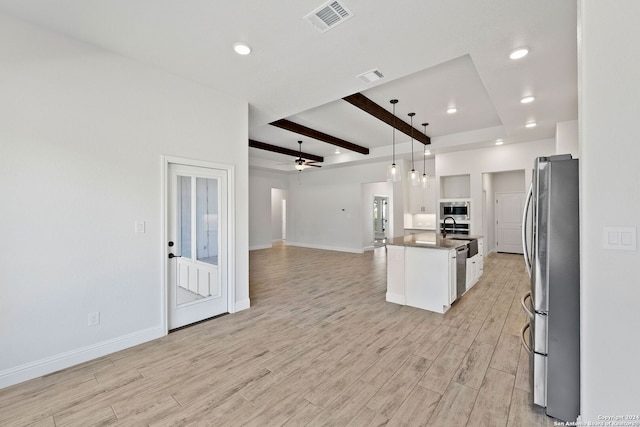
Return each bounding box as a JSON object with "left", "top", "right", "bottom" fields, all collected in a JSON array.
[{"left": 287, "top": 163, "right": 403, "bottom": 252}]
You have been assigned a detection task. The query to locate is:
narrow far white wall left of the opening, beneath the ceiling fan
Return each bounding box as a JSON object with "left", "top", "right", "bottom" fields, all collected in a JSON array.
[{"left": 249, "top": 168, "right": 289, "bottom": 250}]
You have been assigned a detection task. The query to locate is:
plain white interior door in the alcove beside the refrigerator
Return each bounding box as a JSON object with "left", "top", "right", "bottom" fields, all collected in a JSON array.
[{"left": 496, "top": 193, "right": 524, "bottom": 254}]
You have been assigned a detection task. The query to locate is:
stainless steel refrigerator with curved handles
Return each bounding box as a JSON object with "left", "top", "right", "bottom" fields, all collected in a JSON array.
[{"left": 522, "top": 154, "right": 580, "bottom": 421}]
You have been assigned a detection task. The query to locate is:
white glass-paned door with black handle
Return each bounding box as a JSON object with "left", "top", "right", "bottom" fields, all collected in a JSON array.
[{"left": 167, "top": 163, "right": 229, "bottom": 329}]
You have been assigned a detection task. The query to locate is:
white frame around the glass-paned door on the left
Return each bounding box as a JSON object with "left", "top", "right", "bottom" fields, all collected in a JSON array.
[{"left": 160, "top": 155, "right": 236, "bottom": 335}]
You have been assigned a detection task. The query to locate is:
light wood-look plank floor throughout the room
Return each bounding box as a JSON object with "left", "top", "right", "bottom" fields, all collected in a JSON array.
[{"left": 0, "top": 245, "right": 553, "bottom": 427}]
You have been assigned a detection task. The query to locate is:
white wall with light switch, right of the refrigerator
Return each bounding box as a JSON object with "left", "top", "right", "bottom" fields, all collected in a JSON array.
[{"left": 578, "top": 0, "right": 640, "bottom": 421}]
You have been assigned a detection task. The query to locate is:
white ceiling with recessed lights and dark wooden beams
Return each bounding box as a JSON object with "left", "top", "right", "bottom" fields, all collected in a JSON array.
[{"left": 0, "top": 0, "right": 578, "bottom": 170}]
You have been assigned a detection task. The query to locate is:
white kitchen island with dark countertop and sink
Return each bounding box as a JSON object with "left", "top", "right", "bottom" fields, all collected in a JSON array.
[{"left": 386, "top": 232, "right": 482, "bottom": 313}]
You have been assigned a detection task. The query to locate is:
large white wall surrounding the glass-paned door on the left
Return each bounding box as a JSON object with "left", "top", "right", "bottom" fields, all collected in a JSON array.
[{"left": 0, "top": 15, "right": 249, "bottom": 387}]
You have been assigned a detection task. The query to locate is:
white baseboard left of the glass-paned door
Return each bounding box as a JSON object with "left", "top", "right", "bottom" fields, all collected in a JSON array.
[{"left": 0, "top": 326, "right": 166, "bottom": 389}]
